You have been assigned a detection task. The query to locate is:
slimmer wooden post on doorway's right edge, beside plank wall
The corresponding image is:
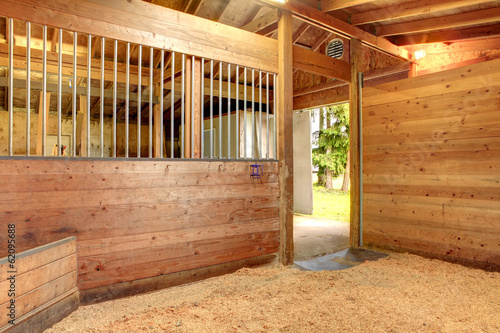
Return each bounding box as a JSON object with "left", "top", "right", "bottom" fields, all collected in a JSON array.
[{"left": 349, "top": 38, "right": 363, "bottom": 247}]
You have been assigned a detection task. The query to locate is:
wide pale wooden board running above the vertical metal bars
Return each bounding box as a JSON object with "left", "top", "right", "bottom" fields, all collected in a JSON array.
[{"left": 0, "top": 0, "right": 278, "bottom": 72}]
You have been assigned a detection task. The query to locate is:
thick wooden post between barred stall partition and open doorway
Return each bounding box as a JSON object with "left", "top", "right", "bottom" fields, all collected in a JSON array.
[{"left": 277, "top": 11, "right": 293, "bottom": 265}]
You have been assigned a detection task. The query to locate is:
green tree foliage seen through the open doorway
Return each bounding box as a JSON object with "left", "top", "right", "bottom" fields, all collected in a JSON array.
[{"left": 312, "top": 104, "right": 349, "bottom": 183}]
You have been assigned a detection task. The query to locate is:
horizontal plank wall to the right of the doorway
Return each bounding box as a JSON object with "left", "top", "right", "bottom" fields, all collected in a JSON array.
[{"left": 363, "top": 60, "right": 500, "bottom": 264}]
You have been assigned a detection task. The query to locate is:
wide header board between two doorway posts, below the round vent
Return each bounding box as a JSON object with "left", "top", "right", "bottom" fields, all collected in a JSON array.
[{"left": 293, "top": 45, "right": 351, "bottom": 82}]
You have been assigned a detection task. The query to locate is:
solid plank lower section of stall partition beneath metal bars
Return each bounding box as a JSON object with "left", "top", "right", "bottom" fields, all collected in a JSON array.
[{"left": 0, "top": 160, "right": 279, "bottom": 290}]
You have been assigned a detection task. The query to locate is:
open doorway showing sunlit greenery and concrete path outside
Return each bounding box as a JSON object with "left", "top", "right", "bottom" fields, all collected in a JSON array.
[{"left": 293, "top": 104, "right": 350, "bottom": 261}]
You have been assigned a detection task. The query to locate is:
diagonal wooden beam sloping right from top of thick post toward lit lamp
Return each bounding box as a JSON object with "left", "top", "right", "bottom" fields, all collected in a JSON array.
[{"left": 285, "top": 1, "right": 410, "bottom": 61}]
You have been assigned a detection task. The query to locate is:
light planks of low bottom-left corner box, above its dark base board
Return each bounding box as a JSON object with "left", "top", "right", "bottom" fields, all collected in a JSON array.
[{"left": 0, "top": 236, "right": 78, "bottom": 332}]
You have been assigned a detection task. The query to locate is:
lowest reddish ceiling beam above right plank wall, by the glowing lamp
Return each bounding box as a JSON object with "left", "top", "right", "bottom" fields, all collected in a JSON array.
[{"left": 395, "top": 24, "right": 500, "bottom": 46}]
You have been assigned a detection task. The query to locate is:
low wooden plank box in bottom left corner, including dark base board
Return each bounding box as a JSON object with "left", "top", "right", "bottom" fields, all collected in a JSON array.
[{"left": 0, "top": 236, "right": 80, "bottom": 333}]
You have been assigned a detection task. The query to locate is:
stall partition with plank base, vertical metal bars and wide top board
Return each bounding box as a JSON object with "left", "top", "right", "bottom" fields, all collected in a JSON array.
[{"left": 0, "top": 1, "right": 279, "bottom": 327}]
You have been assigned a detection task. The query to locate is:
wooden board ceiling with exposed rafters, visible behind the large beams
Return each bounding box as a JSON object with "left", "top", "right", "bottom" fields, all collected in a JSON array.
[{"left": 141, "top": 0, "right": 500, "bottom": 50}]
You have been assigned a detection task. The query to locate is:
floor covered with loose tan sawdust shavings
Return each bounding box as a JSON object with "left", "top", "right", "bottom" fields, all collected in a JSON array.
[{"left": 47, "top": 254, "right": 500, "bottom": 332}]
